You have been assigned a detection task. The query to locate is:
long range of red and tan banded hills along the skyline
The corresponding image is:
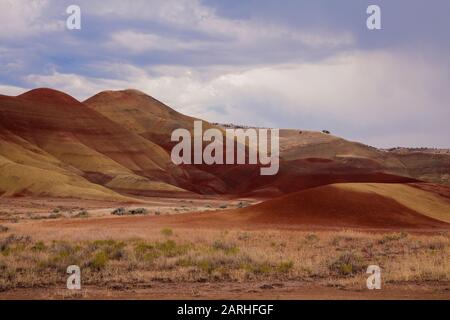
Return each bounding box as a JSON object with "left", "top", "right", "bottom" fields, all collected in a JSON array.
[{"left": 0, "top": 89, "right": 450, "bottom": 202}]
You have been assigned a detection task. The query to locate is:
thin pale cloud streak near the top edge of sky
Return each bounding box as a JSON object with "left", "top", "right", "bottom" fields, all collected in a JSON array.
[{"left": 97, "top": 0, "right": 354, "bottom": 52}]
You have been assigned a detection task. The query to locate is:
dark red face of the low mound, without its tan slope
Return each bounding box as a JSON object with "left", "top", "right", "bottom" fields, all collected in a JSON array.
[{"left": 227, "top": 185, "right": 449, "bottom": 229}]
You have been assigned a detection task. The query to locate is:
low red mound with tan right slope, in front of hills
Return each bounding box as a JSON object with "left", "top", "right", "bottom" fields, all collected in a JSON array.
[{"left": 192, "top": 183, "right": 450, "bottom": 230}]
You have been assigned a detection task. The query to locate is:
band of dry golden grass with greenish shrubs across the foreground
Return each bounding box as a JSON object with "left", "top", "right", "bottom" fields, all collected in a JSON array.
[{"left": 0, "top": 228, "right": 450, "bottom": 290}]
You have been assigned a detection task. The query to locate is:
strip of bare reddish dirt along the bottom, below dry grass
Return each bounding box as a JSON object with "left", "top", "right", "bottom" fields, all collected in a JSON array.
[{"left": 0, "top": 281, "right": 450, "bottom": 300}]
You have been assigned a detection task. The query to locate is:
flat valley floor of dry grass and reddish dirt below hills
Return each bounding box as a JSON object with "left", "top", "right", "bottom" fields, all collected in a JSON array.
[{"left": 0, "top": 198, "right": 450, "bottom": 299}]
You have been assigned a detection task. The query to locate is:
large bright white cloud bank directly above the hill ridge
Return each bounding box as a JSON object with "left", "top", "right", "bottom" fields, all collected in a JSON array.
[{"left": 23, "top": 51, "right": 450, "bottom": 145}]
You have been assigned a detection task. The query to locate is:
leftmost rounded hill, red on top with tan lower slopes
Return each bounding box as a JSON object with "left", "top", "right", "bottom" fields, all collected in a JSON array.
[{"left": 0, "top": 89, "right": 188, "bottom": 197}]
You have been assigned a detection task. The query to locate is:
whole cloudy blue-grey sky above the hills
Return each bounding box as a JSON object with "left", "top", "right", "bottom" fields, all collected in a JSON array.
[{"left": 0, "top": 0, "right": 450, "bottom": 148}]
